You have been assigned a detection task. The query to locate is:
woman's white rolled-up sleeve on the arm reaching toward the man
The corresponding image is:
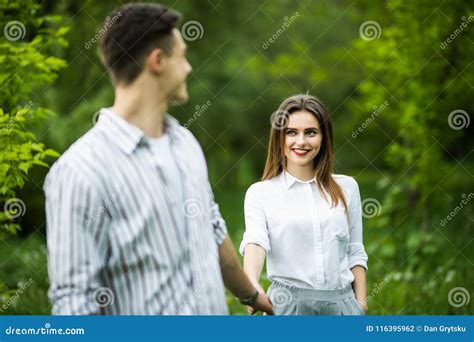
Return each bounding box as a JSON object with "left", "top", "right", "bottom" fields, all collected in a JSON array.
[{"left": 239, "top": 184, "right": 271, "bottom": 255}]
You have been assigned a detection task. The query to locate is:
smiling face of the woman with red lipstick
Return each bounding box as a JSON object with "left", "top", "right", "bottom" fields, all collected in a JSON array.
[{"left": 285, "top": 110, "right": 323, "bottom": 168}]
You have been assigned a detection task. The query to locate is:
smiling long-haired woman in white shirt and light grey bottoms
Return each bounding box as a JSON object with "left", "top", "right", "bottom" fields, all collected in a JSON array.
[{"left": 240, "top": 95, "right": 367, "bottom": 315}]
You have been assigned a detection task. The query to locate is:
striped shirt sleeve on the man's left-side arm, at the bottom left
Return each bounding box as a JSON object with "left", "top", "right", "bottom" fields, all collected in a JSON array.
[{"left": 44, "top": 165, "right": 105, "bottom": 315}]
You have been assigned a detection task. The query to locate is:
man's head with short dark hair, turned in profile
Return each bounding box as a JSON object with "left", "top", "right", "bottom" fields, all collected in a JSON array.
[{"left": 100, "top": 3, "right": 191, "bottom": 102}]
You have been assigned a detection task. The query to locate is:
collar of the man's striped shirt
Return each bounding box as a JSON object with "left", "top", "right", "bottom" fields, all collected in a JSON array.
[{"left": 97, "top": 108, "right": 179, "bottom": 154}]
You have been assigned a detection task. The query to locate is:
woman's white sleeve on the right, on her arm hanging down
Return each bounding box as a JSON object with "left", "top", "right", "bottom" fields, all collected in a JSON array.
[{"left": 348, "top": 180, "right": 368, "bottom": 270}]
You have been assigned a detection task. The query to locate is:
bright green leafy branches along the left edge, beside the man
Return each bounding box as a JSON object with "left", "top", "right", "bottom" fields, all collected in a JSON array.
[{"left": 0, "top": 1, "right": 67, "bottom": 236}]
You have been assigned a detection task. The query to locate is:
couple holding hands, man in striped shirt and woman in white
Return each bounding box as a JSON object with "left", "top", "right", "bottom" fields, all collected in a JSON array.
[{"left": 44, "top": 3, "right": 367, "bottom": 315}]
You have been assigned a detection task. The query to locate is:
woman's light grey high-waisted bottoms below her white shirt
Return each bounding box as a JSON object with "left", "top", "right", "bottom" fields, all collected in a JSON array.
[{"left": 267, "top": 281, "right": 365, "bottom": 316}]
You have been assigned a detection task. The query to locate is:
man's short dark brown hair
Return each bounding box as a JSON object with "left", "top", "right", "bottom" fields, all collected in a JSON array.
[{"left": 100, "top": 3, "right": 181, "bottom": 84}]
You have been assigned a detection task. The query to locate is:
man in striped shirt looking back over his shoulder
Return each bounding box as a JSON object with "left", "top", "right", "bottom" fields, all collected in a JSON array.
[{"left": 45, "top": 3, "right": 273, "bottom": 315}]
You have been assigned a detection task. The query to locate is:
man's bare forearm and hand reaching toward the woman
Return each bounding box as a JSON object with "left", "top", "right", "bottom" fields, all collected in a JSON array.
[{"left": 219, "top": 236, "right": 273, "bottom": 315}]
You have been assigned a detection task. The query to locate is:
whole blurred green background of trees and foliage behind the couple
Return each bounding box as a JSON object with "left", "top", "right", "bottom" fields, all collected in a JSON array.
[{"left": 0, "top": 0, "right": 474, "bottom": 315}]
